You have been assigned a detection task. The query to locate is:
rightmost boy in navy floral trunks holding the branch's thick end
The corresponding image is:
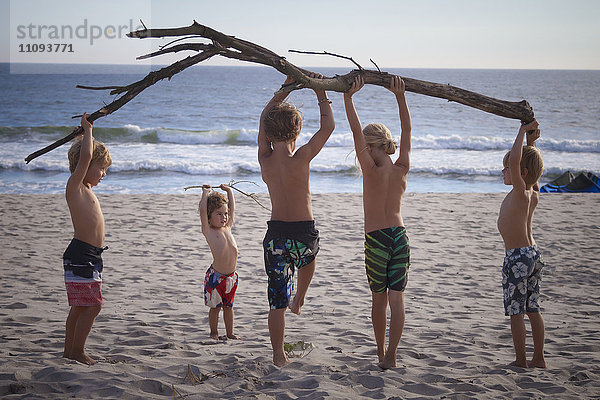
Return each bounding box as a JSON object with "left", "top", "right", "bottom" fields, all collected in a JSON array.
[{"left": 498, "top": 120, "right": 546, "bottom": 368}]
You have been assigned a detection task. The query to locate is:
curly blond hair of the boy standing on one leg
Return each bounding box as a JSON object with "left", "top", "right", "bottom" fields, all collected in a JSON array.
[{"left": 263, "top": 101, "right": 302, "bottom": 142}]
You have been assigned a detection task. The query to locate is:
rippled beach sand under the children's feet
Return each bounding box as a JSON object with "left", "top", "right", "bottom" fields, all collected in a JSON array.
[{"left": 0, "top": 191, "right": 600, "bottom": 399}]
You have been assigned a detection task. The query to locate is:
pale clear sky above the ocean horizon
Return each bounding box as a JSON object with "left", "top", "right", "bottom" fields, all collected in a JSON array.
[{"left": 0, "top": 0, "right": 600, "bottom": 70}]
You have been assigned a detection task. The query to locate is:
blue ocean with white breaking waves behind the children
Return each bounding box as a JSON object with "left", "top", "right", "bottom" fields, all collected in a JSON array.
[{"left": 0, "top": 64, "right": 600, "bottom": 193}]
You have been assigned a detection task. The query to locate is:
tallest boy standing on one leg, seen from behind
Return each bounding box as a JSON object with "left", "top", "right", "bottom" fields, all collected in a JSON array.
[{"left": 258, "top": 74, "right": 334, "bottom": 367}]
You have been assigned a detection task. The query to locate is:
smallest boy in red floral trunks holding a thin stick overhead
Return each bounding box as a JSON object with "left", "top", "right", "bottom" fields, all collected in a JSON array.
[{"left": 198, "top": 185, "right": 239, "bottom": 340}]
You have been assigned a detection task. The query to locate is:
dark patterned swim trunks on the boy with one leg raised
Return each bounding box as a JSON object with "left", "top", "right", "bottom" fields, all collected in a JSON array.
[{"left": 263, "top": 221, "right": 319, "bottom": 310}]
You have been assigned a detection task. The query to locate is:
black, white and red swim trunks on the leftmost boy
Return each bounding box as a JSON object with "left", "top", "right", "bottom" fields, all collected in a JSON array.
[{"left": 63, "top": 239, "right": 104, "bottom": 306}]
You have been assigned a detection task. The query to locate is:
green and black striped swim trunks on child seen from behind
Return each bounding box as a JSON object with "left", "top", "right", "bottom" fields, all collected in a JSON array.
[{"left": 365, "top": 226, "right": 410, "bottom": 293}]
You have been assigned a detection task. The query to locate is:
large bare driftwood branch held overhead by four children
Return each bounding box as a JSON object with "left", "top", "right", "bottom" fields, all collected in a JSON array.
[{"left": 25, "top": 21, "right": 534, "bottom": 163}]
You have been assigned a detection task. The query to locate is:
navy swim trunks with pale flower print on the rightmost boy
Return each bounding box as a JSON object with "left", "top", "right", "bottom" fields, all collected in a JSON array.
[{"left": 502, "top": 245, "right": 544, "bottom": 316}]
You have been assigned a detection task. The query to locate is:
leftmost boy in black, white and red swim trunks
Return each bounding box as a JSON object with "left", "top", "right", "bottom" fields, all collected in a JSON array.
[{"left": 63, "top": 113, "right": 112, "bottom": 365}]
